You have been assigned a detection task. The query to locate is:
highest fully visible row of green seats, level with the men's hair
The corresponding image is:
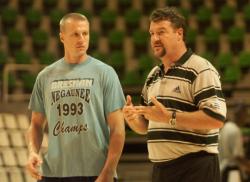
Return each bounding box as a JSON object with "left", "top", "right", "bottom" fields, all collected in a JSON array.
[{"left": 1, "top": 4, "right": 250, "bottom": 36}]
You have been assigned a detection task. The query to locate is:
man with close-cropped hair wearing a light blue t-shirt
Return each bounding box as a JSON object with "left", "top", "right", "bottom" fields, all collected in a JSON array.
[{"left": 27, "top": 13, "right": 125, "bottom": 182}]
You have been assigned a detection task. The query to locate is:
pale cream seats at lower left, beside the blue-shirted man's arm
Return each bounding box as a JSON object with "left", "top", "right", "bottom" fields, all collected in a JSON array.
[{"left": 0, "top": 113, "right": 48, "bottom": 182}]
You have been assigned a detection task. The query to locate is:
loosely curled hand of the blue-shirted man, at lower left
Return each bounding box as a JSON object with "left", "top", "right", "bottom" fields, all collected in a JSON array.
[{"left": 26, "top": 152, "right": 42, "bottom": 180}]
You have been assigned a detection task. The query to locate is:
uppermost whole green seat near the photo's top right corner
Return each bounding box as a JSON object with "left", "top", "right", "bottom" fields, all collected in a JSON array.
[{"left": 219, "top": 4, "right": 236, "bottom": 33}]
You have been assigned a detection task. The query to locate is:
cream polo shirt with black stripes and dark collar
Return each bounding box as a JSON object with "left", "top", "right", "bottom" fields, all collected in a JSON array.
[{"left": 141, "top": 49, "right": 226, "bottom": 162}]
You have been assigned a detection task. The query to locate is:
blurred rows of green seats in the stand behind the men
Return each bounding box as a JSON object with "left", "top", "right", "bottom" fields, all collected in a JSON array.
[{"left": 0, "top": 0, "right": 250, "bottom": 102}]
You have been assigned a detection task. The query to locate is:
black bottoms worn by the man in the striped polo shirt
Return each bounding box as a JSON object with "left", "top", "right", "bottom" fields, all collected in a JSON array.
[{"left": 152, "top": 152, "right": 220, "bottom": 182}]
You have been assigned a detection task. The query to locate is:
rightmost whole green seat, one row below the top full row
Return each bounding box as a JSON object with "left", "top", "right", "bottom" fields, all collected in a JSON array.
[{"left": 228, "top": 26, "right": 245, "bottom": 54}]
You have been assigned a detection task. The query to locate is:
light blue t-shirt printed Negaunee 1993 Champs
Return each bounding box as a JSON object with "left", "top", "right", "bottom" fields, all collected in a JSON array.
[{"left": 29, "top": 56, "right": 125, "bottom": 177}]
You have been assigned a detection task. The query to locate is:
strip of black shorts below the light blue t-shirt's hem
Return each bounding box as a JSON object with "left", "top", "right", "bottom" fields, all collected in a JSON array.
[{"left": 37, "top": 176, "right": 117, "bottom": 182}]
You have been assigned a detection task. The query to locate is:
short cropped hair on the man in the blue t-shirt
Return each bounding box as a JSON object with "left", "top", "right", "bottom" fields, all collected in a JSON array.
[{"left": 59, "top": 13, "right": 89, "bottom": 32}]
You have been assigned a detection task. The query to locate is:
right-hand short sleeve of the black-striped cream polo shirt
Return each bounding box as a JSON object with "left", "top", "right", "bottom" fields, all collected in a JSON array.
[{"left": 193, "top": 66, "right": 226, "bottom": 121}]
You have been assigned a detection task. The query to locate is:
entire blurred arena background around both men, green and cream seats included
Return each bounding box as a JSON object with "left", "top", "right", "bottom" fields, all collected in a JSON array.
[{"left": 0, "top": 0, "right": 250, "bottom": 182}]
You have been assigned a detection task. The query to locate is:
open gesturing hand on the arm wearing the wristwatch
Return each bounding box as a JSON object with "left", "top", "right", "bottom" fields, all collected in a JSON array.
[{"left": 134, "top": 97, "right": 170, "bottom": 122}]
